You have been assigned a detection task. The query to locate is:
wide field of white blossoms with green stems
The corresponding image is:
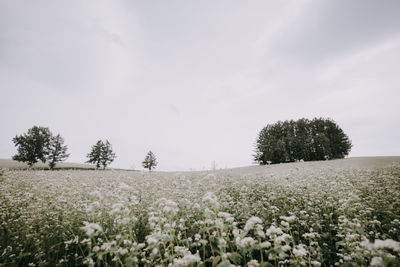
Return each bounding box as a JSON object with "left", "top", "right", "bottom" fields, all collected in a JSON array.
[{"left": 0, "top": 157, "right": 400, "bottom": 267}]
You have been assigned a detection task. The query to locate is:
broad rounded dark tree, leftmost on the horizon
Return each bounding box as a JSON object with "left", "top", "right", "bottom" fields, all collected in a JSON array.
[{"left": 12, "top": 126, "right": 52, "bottom": 167}]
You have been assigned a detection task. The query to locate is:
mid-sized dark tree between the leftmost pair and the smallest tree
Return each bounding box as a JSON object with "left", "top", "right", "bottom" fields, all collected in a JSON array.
[{"left": 86, "top": 140, "right": 116, "bottom": 169}]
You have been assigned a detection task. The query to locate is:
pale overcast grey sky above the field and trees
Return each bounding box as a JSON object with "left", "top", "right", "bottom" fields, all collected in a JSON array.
[{"left": 0, "top": 0, "right": 400, "bottom": 171}]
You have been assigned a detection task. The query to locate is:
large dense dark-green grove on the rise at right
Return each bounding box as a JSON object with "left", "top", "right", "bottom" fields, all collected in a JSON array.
[{"left": 254, "top": 118, "right": 352, "bottom": 165}]
